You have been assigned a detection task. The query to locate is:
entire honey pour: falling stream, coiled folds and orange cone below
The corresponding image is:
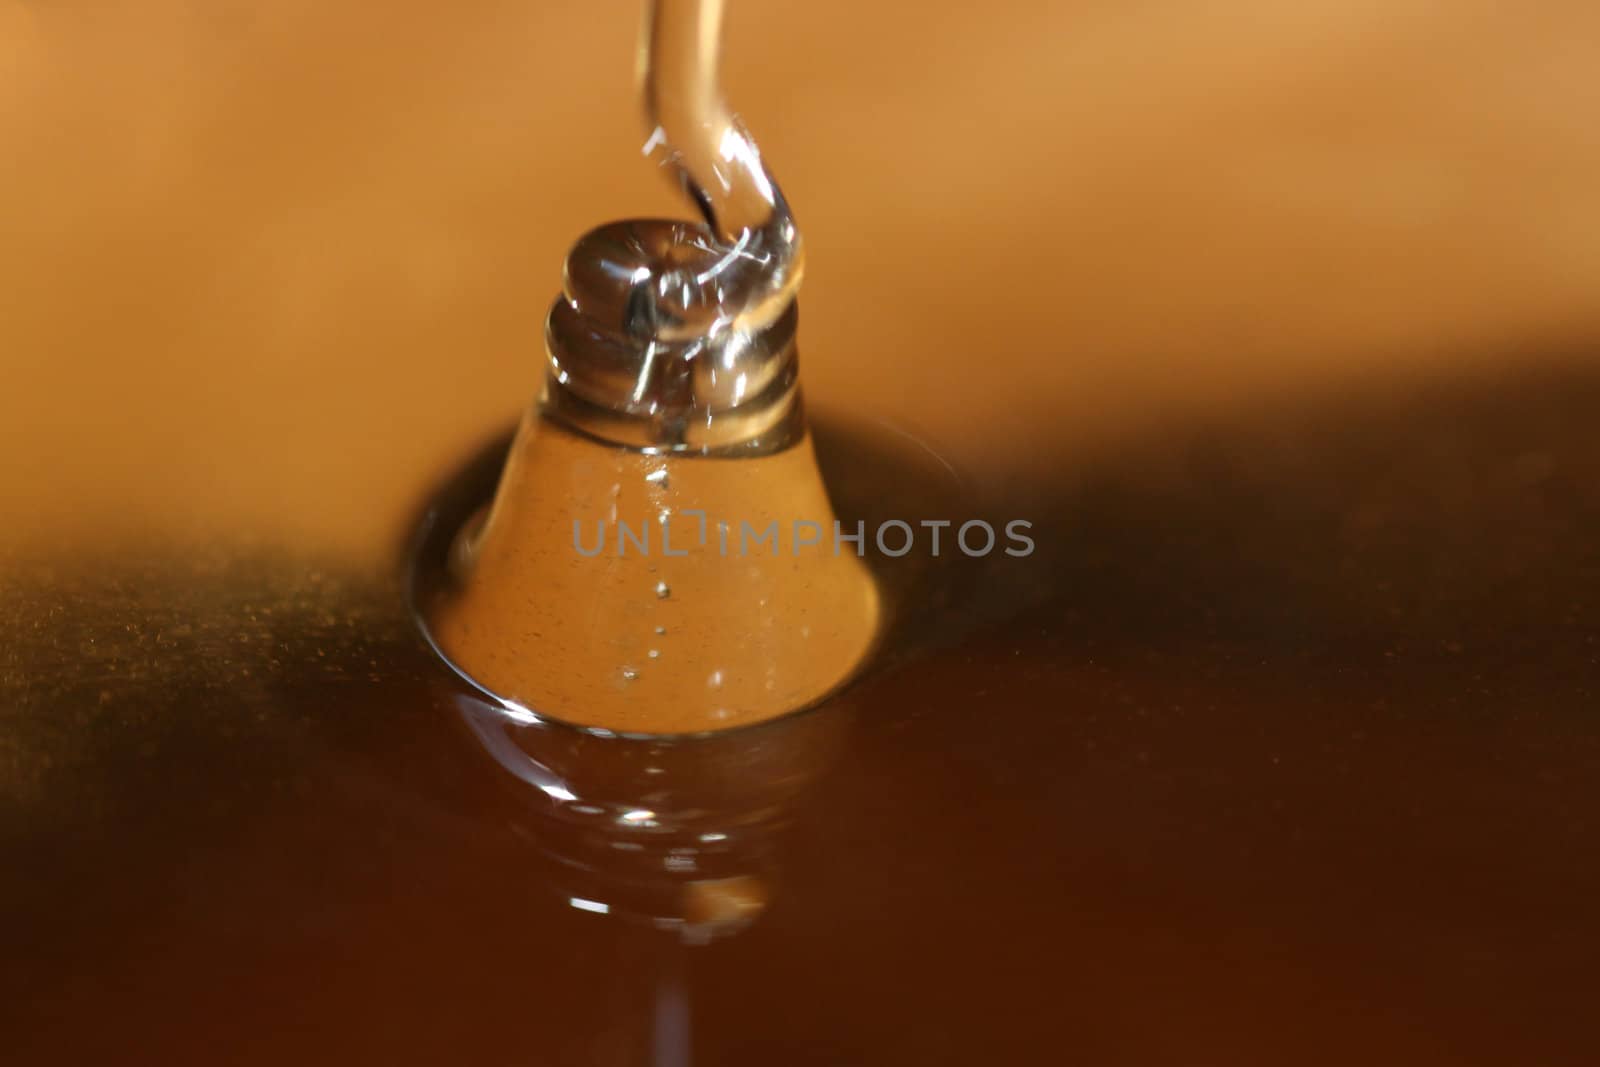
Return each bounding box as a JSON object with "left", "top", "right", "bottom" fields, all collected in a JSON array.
[{"left": 432, "top": 0, "right": 880, "bottom": 734}]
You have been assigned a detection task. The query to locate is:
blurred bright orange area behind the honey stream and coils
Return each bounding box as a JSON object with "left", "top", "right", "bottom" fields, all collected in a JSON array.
[{"left": 0, "top": 0, "right": 1600, "bottom": 552}]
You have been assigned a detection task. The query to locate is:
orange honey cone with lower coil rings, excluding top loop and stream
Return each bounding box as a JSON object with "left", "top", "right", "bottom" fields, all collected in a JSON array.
[{"left": 430, "top": 254, "right": 882, "bottom": 734}]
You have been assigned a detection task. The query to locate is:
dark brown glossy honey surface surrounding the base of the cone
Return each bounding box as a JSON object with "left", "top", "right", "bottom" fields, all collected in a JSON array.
[{"left": 9, "top": 363, "right": 1600, "bottom": 1065}]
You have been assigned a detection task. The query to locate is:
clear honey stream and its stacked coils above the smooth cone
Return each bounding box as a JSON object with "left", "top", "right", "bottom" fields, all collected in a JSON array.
[{"left": 546, "top": 0, "right": 803, "bottom": 451}]
